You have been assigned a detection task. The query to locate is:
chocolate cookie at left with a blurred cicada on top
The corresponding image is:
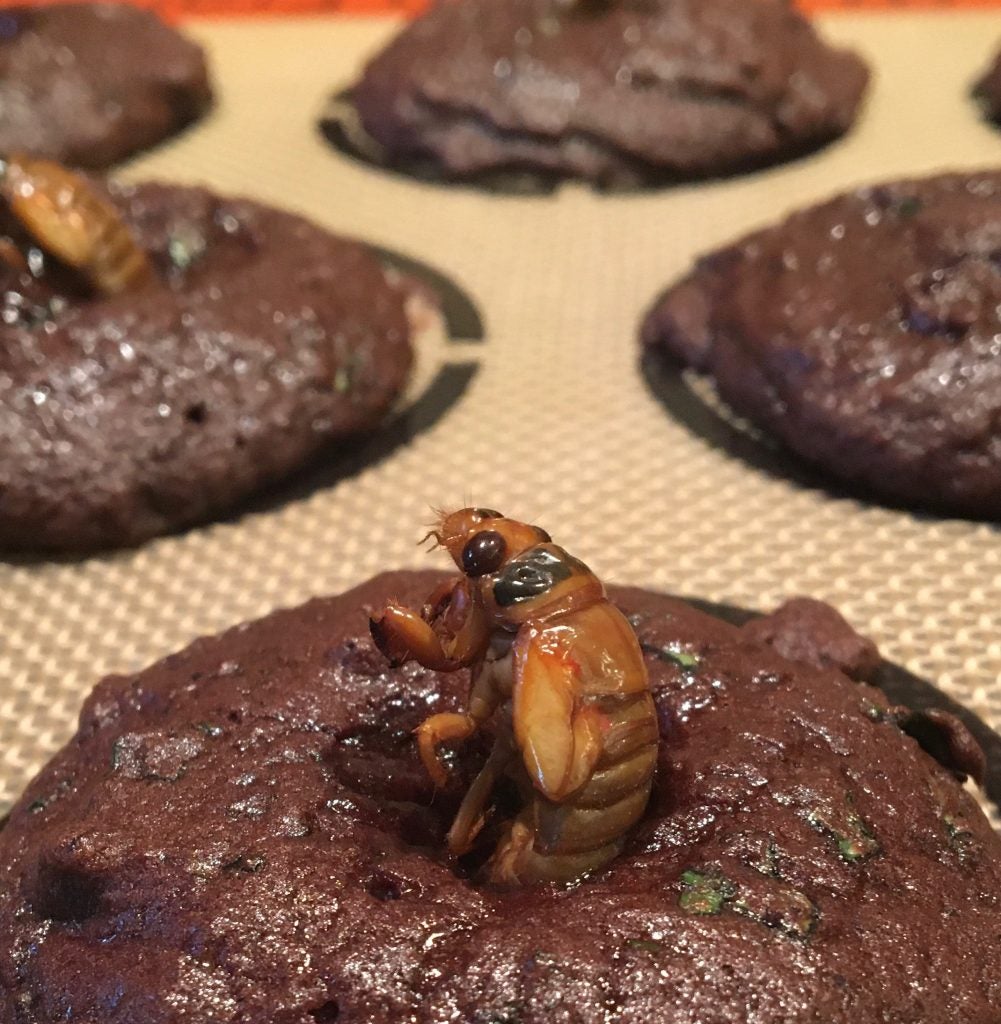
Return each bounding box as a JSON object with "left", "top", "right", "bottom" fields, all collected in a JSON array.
[{"left": 0, "top": 184, "right": 411, "bottom": 551}]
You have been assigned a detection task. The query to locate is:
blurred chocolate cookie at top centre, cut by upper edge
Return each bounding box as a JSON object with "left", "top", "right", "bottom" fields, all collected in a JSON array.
[{"left": 328, "top": 0, "right": 868, "bottom": 186}]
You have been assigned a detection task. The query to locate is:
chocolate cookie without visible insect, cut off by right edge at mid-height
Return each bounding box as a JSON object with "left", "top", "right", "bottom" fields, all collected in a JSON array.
[{"left": 643, "top": 173, "right": 1001, "bottom": 519}]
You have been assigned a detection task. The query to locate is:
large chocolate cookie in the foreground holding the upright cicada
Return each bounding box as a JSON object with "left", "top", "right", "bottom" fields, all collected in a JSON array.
[{"left": 0, "top": 573, "right": 1001, "bottom": 1024}]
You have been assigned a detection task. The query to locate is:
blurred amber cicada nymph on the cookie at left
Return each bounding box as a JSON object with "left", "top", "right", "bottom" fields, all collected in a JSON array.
[{"left": 0, "top": 155, "right": 153, "bottom": 295}]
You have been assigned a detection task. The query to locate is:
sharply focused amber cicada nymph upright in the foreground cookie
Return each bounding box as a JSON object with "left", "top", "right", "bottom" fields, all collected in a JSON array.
[{"left": 372, "top": 509, "right": 658, "bottom": 885}]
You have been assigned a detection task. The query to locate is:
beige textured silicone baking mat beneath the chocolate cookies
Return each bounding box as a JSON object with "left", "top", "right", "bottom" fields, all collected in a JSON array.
[{"left": 0, "top": 13, "right": 1001, "bottom": 831}]
